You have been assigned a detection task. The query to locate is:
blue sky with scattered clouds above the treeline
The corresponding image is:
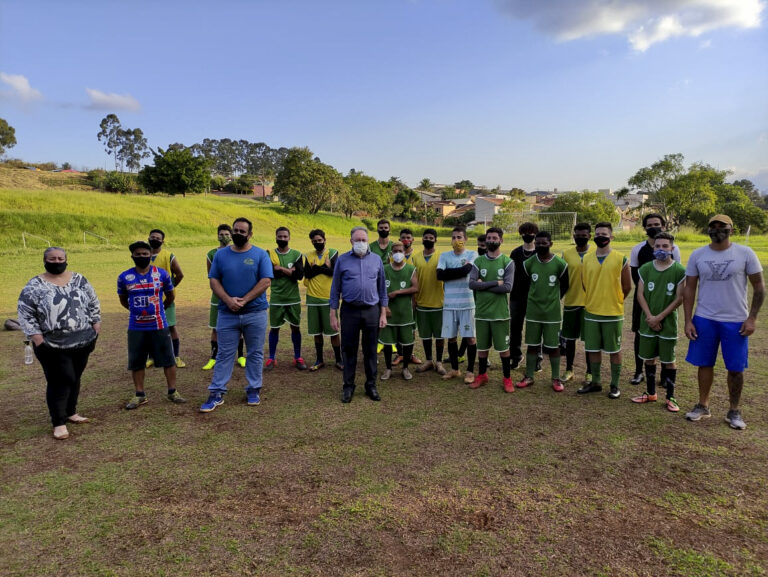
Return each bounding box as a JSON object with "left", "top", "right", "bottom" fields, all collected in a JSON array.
[{"left": 0, "top": 0, "right": 768, "bottom": 193}]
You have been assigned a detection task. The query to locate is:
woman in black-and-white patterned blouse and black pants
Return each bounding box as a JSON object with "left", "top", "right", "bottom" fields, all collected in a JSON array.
[{"left": 18, "top": 247, "right": 101, "bottom": 439}]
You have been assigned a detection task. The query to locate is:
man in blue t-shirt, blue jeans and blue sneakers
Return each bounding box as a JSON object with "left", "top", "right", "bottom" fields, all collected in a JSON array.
[{"left": 200, "top": 217, "right": 272, "bottom": 413}]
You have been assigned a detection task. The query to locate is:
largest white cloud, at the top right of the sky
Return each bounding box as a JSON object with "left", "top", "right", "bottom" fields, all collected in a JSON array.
[{"left": 496, "top": 0, "right": 765, "bottom": 52}]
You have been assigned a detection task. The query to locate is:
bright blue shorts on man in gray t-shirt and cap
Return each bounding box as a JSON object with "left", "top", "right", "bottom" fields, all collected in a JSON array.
[{"left": 685, "top": 316, "right": 749, "bottom": 373}]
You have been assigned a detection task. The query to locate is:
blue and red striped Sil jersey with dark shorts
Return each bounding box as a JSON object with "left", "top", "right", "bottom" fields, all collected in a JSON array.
[{"left": 117, "top": 266, "right": 176, "bottom": 371}]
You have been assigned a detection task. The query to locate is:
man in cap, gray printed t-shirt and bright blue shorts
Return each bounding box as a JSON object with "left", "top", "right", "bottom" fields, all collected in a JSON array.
[{"left": 683, "top": 214, "right": 765, "bottom": 429}]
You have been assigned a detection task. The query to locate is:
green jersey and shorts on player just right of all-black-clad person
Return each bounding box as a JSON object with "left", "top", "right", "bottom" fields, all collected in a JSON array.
[{"left": 523, "top": 255, "right": 568, "bottom": 349}]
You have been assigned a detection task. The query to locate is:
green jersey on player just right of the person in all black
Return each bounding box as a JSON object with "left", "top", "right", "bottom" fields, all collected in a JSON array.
[{"left": 523, "top": 255, "right": 568, "bottom": 323}]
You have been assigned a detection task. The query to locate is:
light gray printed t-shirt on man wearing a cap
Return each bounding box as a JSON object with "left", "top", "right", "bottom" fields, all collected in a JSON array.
[{"left": 685, "top": 244, "right": 763, "bottom": 323}]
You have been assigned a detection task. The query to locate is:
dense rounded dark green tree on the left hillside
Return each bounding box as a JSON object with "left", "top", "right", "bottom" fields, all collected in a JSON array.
[{"left": 139, "top": 148, "right": 211, "bottom": 195}]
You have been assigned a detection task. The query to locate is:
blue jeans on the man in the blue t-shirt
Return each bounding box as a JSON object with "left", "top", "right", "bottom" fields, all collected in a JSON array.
[{"left": 208, "top": 309, "right": 267, "bottom": 393}]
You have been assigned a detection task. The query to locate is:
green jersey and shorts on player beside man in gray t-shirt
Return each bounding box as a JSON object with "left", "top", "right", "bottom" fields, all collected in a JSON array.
[{"left": 637, "top": 260, "right": 685, "bottom": 339}]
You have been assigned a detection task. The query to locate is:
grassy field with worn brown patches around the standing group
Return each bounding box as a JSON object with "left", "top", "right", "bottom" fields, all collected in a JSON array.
[{"left": 0, "top": 187, "right": 768, "bottom": 576}]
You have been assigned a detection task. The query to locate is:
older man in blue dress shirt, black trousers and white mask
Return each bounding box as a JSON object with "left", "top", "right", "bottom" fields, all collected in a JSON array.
[{"left": 331, "top": 226, "right": 389, "bottom": 403}]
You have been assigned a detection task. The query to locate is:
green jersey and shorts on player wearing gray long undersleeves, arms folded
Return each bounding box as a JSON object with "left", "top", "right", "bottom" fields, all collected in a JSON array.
[{"left": 470, "top": 254, "right": 515, "bottom": 353}]
